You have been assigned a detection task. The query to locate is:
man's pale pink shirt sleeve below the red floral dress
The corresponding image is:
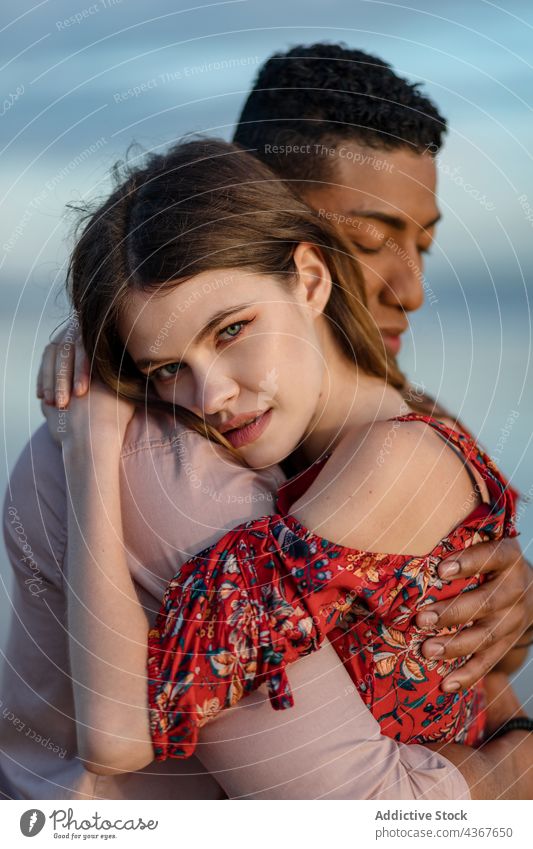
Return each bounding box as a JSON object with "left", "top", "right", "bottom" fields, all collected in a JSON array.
[{"left": 196, "top": 640, "right": 470, "bottom": 799}]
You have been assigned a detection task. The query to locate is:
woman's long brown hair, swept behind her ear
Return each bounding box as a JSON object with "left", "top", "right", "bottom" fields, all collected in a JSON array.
[{"left": 68, "top": 139, "right": 405, "bottom": 459}]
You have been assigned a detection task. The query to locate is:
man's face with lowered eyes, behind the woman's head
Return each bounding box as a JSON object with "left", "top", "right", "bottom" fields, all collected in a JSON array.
[{"left": 305, "top": 143, "right": 439, "bottom": 356}]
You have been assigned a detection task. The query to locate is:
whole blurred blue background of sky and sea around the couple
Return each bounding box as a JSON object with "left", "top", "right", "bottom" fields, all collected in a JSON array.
[{"left": 0, "top": 0, "right": 533, "bottom": 691}]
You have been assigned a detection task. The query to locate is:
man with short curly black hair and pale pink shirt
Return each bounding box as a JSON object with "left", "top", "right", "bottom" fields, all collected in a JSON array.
[{"left": 0, "top": 39, "right": 529, "bottom": 798}]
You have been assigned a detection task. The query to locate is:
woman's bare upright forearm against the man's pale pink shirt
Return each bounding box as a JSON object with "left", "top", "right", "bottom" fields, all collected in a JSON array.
[{"left": 63, "top": 428, "right": 153, "bottom": 773}]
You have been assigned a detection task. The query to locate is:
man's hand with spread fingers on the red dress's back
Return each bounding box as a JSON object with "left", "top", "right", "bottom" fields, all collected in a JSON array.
[{"left": 416, "top": 539, "right": 533, "bottom": 692}]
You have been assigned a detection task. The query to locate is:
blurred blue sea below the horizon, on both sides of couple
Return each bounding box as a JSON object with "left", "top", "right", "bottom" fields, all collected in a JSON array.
[{"left": 0, "top": 278, "right": 533, "bottom": 708}]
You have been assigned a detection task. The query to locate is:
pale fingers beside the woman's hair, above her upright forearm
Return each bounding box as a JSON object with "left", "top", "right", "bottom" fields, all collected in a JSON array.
[{"left": 37, "top": 317, "right": 90, "bottom": 407}]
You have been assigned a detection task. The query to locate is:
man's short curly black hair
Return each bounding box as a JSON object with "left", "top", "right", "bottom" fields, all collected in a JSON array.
[{"left": 234, "top": 42, "right": 446, "bottom": 180}]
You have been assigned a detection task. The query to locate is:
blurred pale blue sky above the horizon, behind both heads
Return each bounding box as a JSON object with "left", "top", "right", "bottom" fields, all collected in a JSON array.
[{"left": 0, "top": 0, "right": 533, "bottom": 294}]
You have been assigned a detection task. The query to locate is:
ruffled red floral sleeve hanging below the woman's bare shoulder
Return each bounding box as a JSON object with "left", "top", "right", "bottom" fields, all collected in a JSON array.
[{"left": 148, "top": 514, "right": 361, "bottom": 760}]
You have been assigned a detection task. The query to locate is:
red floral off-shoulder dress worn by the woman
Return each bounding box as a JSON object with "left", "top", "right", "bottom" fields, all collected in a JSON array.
[{"left": 148, "top": 414, "right": 516, "bottom": 760}]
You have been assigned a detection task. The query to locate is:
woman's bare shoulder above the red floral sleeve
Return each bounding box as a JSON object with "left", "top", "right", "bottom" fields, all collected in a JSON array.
[{"left": 291, "top": 420, "right": 478, "bottom": 554}]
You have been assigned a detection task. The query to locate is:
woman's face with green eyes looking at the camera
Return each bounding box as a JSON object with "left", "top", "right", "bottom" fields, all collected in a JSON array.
[{"left": 119, "top": 245, "right": 330, "bottom": 468}]
